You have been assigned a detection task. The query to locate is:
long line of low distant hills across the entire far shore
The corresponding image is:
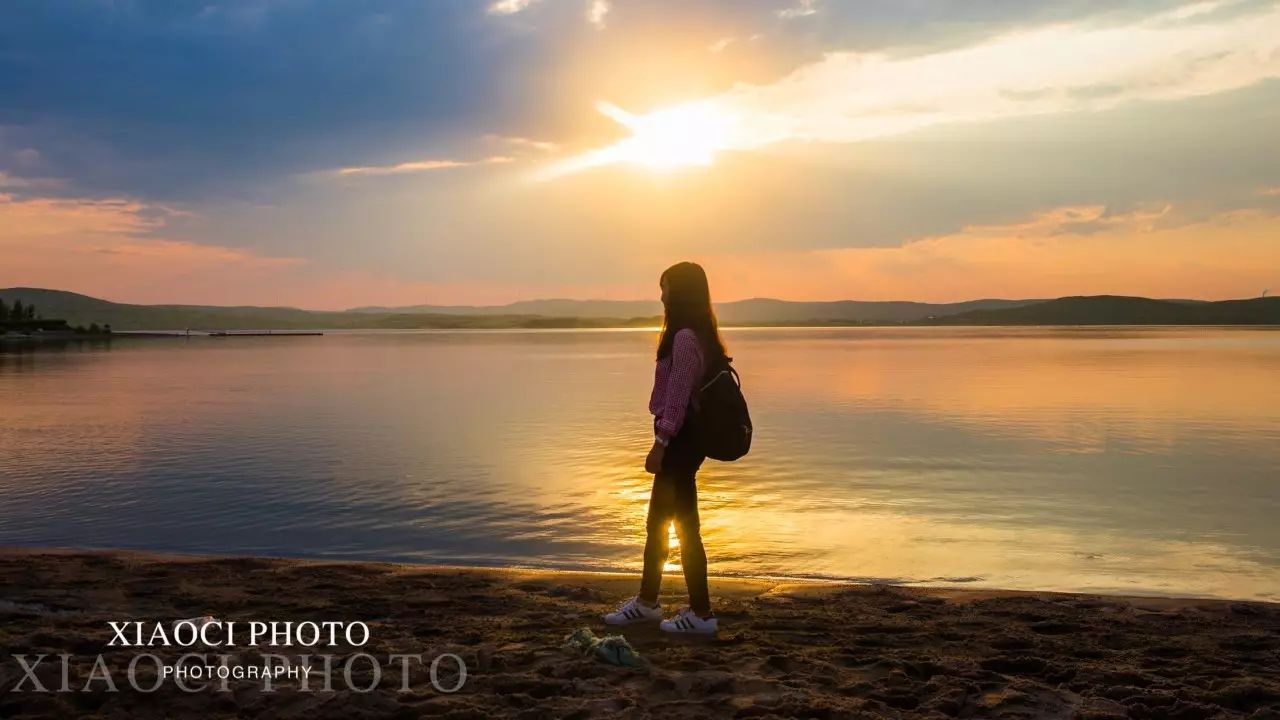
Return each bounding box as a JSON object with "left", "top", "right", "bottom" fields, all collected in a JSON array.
[{"left": 0, "top": 287, "right": 1280, "bottom": 331}]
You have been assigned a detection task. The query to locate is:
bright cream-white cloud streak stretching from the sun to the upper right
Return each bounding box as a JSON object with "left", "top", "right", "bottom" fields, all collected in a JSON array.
[{"left": 550, "top": 4, "right": 1280, "bottom": 177}]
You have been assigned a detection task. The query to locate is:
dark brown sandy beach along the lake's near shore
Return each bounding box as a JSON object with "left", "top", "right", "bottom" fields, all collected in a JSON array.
[{"left": 0, "top": 548, "right": 1280, "bottom": 720}]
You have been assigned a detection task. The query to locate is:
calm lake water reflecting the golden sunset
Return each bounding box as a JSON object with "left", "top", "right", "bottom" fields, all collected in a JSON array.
[{"left": 0, "top": 328, "right": 1280, "bottom": 600}]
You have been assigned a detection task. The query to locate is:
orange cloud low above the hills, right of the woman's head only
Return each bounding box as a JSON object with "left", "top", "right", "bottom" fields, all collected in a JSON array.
[{"left": 703, "top": 206, "right": 1280, "bottom": 302}]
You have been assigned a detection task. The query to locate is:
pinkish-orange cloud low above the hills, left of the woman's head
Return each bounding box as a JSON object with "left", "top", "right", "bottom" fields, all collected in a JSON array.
[{"left": 0, "top": 193, "right": 652, "bottom": 310}]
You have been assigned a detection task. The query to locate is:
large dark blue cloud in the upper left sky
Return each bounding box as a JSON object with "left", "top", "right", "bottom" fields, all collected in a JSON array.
[{"left": 0, "top": 0, "right": 550, "bottom": 197}]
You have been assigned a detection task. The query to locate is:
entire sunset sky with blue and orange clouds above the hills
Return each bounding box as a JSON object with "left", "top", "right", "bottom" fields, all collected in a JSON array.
[{"left": 0, "top": 0, "right": 1280, "bottom": 309}]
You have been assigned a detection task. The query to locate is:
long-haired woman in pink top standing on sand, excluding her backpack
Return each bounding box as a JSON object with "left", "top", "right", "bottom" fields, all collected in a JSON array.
[{"left": 604, "top": 263, "right": 726, "bottom": 633}]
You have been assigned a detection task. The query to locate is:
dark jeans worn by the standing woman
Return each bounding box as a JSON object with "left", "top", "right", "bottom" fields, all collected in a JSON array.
[{"left": 640, "top": 422, "right": 712, "bottom": 615}]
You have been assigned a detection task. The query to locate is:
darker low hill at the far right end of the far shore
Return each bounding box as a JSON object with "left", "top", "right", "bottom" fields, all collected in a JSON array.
[{"left": 920, "top": 295, "right": 1280, "bottom": 325}]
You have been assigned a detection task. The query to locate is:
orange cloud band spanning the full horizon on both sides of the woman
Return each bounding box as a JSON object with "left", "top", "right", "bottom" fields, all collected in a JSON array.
[{"left": 0, "top": 193, "right": 1280, "bottom": 309}]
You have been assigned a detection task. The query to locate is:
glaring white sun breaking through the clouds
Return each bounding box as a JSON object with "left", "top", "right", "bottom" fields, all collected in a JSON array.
[{"left": 543, "top": 101, "right": 735, "bottom": 178}]
